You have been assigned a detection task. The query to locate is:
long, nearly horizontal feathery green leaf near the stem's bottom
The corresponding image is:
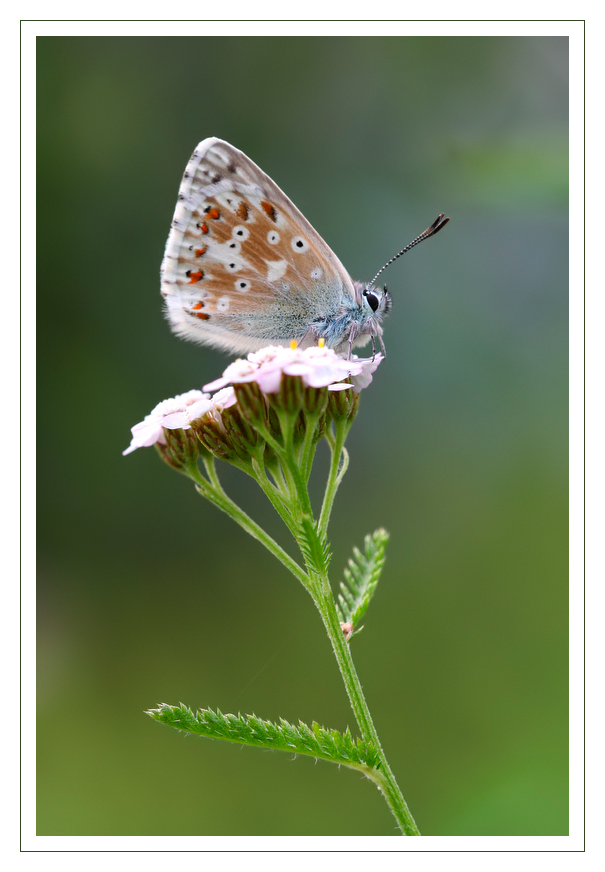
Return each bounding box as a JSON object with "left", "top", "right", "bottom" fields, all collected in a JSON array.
[{"left": 146, "top": 703, "right": 378, "bottom": 774}]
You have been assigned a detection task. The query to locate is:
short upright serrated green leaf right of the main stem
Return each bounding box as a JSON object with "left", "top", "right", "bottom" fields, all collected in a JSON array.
[{"left": 337, "top": 529, "right": 389, "bottom": 632}]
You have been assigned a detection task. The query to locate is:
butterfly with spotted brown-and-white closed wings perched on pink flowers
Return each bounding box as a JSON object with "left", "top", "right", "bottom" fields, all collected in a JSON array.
[{"left": 161, "top": 137, "right": 449, "bottom": 357}]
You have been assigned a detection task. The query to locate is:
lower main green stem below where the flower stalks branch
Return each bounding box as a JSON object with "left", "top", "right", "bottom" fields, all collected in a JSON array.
[{"left": 311, "top": 575, "right": 420, "bottom": 836}]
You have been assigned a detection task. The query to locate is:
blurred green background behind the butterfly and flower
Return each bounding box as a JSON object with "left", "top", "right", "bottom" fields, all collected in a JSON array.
[{"left": 37, "top": 37, "right": 568, "bottom": 836}]
